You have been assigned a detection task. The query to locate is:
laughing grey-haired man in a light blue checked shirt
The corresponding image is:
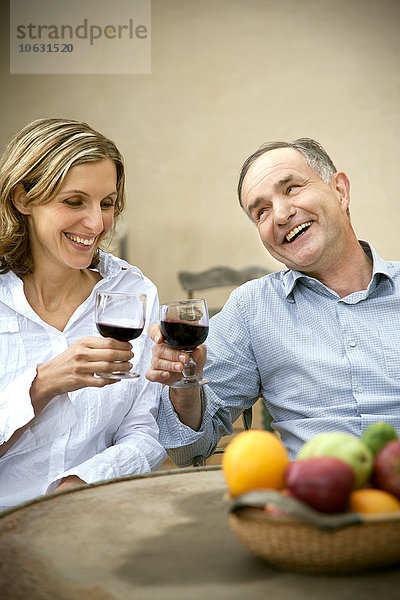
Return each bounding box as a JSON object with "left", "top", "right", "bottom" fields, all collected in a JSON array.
[{"left": 147, "top": 138, "right": 400, "bottom": 465}]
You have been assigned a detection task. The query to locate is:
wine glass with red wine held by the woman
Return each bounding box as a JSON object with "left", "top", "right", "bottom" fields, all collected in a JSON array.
[{"left": 95, "top": 292, "right": 147, "bottom": 379}]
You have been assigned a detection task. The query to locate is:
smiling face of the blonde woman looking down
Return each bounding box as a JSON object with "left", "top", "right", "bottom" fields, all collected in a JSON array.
[{"left": 20, "top": 158, "right": 117, "bottom": 269}]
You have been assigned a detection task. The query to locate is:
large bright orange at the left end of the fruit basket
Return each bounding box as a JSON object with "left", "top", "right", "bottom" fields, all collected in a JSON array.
[{"left": 222, "top": 429, "right": 289, "bottom": 496}]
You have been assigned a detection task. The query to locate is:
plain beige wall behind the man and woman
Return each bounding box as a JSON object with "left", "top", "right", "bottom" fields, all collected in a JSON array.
[{"left": 0, "top": 0, "right": 400, "bottom": 302}]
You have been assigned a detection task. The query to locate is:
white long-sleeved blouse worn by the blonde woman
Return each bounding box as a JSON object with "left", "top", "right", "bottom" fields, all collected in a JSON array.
[{"left": 0, "top": 252, "right": 166, "bottom": 510}]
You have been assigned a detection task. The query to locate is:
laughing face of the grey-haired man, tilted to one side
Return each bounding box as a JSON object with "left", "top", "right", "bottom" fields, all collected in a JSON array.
[{"left": 241, "top": 148, "right": 349, "bottom": 277}]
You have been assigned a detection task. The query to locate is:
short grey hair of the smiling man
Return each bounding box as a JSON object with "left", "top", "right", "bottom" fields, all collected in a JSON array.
[{"left": 237, "top": 138, "right": 337, "bottom": 208}]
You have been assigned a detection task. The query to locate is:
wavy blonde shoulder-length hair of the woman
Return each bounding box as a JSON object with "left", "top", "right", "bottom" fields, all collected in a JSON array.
[{"left": 0, "top": 119, "right": 126, "bottom": 276}]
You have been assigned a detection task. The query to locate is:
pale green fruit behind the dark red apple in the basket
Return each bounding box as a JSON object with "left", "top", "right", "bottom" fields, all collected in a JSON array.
[{"left": 296, "top": 431, "right": 374, "bottom": 488}]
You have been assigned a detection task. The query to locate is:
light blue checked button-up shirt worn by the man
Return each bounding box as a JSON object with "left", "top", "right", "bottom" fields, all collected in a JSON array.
[{"left": 158, "top": 242, "right": 400, "bottom": 466}]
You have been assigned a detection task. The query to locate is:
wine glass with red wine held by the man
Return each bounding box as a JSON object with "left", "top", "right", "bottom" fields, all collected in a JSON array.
[{"left": 160, "top": 299, "right": 209, "bottom": 388}]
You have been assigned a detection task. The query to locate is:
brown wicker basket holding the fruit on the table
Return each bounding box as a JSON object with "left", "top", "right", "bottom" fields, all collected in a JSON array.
[{"left": 229, "top": 490, "right": 400, "bottom": 574}]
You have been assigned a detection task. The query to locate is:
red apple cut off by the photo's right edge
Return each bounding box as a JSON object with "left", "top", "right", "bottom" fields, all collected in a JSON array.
[{"left": 373, "top": 440, "right": 400, "bottom": 500}]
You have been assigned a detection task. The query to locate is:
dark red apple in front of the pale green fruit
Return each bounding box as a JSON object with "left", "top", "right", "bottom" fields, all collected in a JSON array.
[{"left": 285, "top": 456, "right": 355, "bottom": 513}]
